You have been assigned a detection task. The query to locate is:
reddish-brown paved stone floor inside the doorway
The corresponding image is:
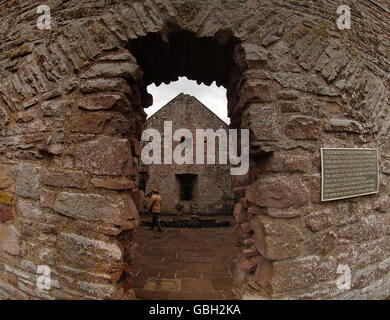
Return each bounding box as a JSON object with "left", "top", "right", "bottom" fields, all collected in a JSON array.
[{"left": 133, "top": 218, "right": 239, "bottom": 300}]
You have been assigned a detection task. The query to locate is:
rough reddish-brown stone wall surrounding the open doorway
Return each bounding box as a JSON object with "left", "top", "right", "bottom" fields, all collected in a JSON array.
[{"left": 0, "top": 0, "right": 390, "bottom": 299}]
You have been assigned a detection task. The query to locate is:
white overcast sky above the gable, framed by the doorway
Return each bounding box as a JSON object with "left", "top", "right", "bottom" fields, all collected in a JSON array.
[{"left": 145, "top": 77, "right": 230, "bottom": 124}]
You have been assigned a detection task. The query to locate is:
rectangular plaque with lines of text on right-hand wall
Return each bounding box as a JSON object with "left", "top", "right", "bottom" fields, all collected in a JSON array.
[{"left": 321, "top": 148, "right": 379, "bottom": 201}]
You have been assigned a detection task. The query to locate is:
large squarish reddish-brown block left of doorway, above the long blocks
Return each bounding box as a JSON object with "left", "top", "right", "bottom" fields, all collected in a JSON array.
[{"left": 76, "top": 137, "right": 132, "bottom": 176}]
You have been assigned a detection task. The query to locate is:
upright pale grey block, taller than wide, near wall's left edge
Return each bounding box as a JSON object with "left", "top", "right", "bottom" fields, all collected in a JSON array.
[{"left": 15, "top": 164, "right": 41, "bottom": 200}]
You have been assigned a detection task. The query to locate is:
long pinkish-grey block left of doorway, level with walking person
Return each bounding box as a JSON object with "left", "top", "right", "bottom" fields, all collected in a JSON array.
[{"left": 54, "top": 192, "right": 138, "bottom": 226}]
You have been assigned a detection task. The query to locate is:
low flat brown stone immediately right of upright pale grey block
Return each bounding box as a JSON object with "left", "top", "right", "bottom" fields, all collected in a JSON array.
[{"left": 41, "top": 170, "right": 88, "bottom": 189}]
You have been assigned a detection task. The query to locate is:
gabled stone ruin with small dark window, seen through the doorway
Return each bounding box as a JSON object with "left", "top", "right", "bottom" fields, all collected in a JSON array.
[{"left": 140, "top": 94, "right": 234, "bottom": 215}]
